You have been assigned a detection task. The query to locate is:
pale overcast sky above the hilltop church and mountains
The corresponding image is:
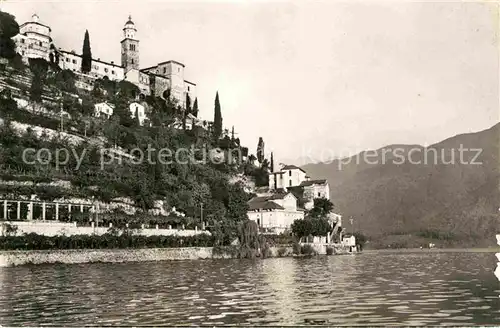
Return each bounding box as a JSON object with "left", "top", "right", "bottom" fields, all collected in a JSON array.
[{"left": 0, "top": 0, "right": 499, "bottom": 161}]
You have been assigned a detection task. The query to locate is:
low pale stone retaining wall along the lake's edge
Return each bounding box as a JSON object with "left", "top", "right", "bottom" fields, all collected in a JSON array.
[{"left": 0, "top": 245, "right": 355, "bottom": 268}]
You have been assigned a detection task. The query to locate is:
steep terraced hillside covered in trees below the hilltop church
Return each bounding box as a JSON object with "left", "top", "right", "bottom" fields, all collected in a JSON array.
[{"left": 0, "top": 7, "right": 270, "bottom": 243}]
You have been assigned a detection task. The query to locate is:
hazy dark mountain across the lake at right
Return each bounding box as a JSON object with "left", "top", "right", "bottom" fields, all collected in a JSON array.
[{"left": 303, "top": 124, "right": 500, "bottom": 245}]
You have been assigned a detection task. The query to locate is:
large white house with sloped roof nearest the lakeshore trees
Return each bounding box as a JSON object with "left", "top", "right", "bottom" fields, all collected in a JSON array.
[{"left": 247, "top": 193, "right": 304, "bottom": 233}]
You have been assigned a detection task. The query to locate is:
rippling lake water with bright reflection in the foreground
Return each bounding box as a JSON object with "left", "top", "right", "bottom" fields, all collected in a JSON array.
[{"left": 0, "top": 251, "right": 500, "bottom": 326}]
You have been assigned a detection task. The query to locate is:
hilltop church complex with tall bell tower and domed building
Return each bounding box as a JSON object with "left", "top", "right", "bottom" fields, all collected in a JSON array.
[{"left": 13, "top": 14, "right": 196, "bottom": 108}]
